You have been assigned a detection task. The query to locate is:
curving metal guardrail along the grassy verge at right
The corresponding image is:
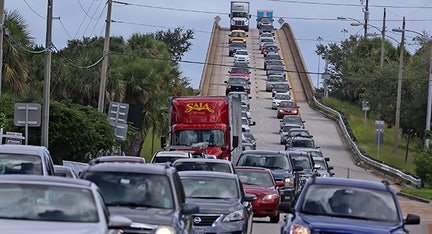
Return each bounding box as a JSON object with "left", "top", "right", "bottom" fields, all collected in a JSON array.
[{"left": 313, "top": 97, "right": 422, "bottom": 188}]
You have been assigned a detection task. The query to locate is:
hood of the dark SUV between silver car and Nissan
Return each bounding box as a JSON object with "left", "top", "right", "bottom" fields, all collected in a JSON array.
[{"left": 108, "top": 206, "right": 175, "bottom": 226}]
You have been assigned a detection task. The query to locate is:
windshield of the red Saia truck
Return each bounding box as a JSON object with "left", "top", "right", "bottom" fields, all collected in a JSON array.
[{"left": 174, "top": 129, "right": 224, "bottom": 147}]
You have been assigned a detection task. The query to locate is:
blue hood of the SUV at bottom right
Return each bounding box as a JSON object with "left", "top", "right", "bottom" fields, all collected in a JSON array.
[{"left": 299, "top": 214, "right": 401, "bottom": 234}]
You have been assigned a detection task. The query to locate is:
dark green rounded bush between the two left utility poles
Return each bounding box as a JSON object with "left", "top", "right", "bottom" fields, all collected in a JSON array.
[{"left": 49, "top": 101, "right": 115, "bottom": 163}]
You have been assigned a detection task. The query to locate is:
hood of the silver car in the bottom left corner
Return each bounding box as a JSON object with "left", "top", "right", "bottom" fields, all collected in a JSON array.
[{"left": 0, "top": 219, "right": 107, "bottom": 234}]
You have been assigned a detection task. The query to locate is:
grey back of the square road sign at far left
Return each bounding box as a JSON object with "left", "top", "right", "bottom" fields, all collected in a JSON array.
[{"left": 14, "top": 103, "right": 41, "bottom": 127}]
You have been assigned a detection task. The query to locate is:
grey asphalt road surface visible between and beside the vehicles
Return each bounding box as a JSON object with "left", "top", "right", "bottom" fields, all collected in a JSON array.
[{"left": 205, "top": 26, "right": 432, "bottom": 234}]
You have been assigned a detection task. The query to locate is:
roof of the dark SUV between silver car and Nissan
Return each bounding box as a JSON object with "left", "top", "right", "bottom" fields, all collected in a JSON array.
[{"left": 83, "top": 162, "right": 175, "bottom": 175}]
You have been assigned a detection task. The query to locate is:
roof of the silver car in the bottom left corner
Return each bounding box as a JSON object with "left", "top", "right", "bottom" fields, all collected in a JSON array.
[{"left": 0, "top": 174, "right": 92, "bottom": 187}]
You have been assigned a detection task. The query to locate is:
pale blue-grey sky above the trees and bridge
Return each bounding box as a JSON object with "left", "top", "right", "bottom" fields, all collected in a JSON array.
[{"left": 5, "top": 0, "right": 432, "bottom": 88}]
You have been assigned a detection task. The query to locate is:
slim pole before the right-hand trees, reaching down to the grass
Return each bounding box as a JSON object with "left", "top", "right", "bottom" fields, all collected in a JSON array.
[{"left": 393, "top": 17, "right": 405, "bottom": 154}]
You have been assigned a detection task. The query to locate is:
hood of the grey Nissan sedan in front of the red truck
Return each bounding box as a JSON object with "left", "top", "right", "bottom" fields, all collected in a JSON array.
[{"left": 186, "top": 198, "right": 243, "bottom": 214}]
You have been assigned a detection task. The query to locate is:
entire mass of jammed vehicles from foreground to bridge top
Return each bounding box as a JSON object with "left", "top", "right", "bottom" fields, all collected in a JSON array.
[{"left": 0, "top": 1, "right": 421, "bottom": 234}]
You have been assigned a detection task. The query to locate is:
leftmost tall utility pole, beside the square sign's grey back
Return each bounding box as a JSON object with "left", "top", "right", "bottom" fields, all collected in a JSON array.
[{"left": 42, "top": 0, "right": 53, "bottom": 148}]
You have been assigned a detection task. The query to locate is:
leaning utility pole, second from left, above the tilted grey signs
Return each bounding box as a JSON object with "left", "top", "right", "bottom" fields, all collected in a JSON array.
[{"left": 98, "top": 0, "right": 112, "bottom": 112}]
